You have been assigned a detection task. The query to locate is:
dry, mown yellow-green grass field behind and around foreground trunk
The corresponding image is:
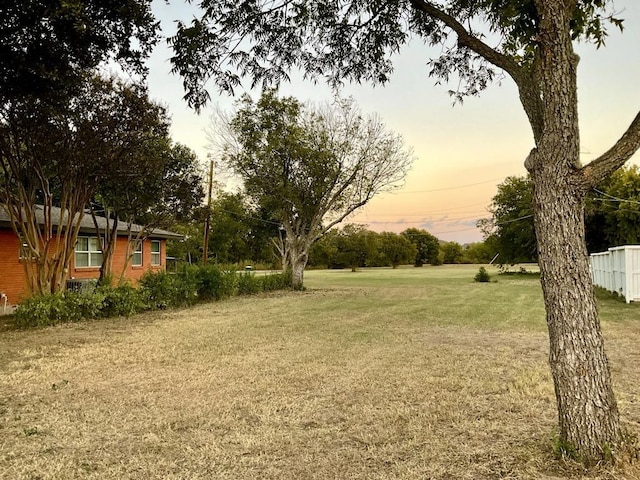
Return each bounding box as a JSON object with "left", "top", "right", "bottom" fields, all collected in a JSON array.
[{"left": 0, "top": 266, "right": 640, "bottom": 480}]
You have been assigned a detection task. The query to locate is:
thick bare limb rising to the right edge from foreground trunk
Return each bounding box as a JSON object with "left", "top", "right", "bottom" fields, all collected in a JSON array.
[{"left": 578, "top": 112, "right": 640, "bottom": 190}]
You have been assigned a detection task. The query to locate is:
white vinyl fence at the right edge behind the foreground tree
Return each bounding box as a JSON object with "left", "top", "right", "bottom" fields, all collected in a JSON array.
[{"left": 591, "top": 245, "right": 640, "bottom": 303}]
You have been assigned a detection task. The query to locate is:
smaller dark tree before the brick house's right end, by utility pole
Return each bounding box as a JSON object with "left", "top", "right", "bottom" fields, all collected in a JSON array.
[{"left": 90, "top": 138, "right": 204, "bottom": 281}]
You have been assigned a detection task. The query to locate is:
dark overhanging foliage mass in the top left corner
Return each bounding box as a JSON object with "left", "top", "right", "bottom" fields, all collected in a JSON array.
[{"left": 0, "top": 0, "right": 158, "bottom": 103}]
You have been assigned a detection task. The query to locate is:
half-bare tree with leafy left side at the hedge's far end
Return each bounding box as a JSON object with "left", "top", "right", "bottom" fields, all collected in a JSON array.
[{"left": 224, "top": 90, "right": 412, "bottom": 289}]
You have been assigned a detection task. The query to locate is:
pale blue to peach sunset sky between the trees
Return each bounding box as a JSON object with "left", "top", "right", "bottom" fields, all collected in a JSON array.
[{"left": 142, "top": 0, "right": 640, "bottom": 244}]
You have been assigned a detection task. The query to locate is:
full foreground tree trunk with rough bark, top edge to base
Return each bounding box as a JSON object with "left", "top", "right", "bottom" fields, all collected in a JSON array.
[{"left": 526, "top": 0, "right": 622, "bottom": 464}]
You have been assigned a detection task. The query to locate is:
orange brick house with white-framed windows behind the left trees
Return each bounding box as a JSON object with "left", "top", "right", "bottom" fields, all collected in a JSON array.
[{"left": 0, "top": 205, "right": 183, "bottom": 304}]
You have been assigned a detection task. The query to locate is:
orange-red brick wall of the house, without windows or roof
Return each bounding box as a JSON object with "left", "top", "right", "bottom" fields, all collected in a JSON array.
[{"left": 0, "top": 229, "right": 166, "bottom": 307}]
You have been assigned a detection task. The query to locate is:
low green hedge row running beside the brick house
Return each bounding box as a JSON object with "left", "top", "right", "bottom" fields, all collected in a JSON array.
[{"left": 14, "top": 266, "right": 291, "bottom": 328}]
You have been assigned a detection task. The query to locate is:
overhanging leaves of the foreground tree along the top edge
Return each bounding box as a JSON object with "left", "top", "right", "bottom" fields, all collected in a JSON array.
[{"left": 169, "top": 0, "right": 622, "bottom": 108}]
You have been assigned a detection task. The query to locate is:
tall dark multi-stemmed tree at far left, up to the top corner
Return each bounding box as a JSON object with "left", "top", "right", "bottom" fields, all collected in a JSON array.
[{"left": 0, "top": 0, "right": 158, "bottom": 292}]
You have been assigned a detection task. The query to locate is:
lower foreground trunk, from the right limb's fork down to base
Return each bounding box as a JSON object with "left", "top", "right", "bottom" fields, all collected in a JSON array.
[{"left": 532, "top": 159, "right": 621, "bottom": 464}]
